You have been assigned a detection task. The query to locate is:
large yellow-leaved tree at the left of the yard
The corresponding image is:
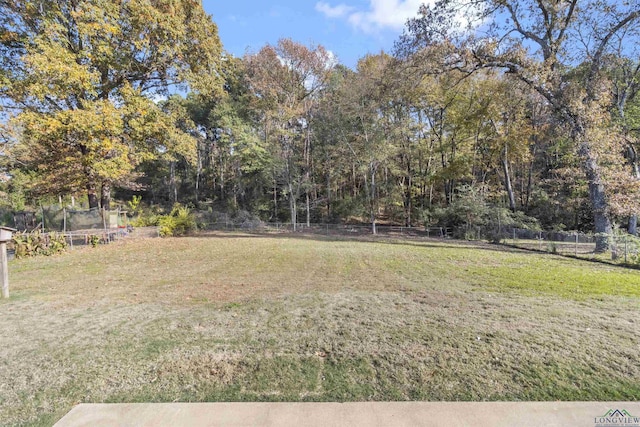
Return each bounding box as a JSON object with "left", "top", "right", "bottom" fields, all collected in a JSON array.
[{"left": 0, "top": 0, "right": 222, "bottom": 208}]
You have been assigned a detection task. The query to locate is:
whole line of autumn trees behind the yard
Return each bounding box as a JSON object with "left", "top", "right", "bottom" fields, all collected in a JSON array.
[{"left": 0, "top": 0, "right": 640, "bottom": 250}]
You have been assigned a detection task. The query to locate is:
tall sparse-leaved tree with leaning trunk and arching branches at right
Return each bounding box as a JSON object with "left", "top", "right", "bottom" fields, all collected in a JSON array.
[{"left": 399, "top": 0, "right": 640, "bottom": 251}]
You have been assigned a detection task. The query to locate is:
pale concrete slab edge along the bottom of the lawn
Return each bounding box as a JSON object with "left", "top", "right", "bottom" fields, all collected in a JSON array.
[{"left": 55, "top": 402, "right": 640, "bottom": 427}]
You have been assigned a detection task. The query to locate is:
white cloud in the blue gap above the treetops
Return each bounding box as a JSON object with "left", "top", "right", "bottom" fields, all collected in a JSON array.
[{"left": 316, "top": 0, "right": 429, "bottom": 33}]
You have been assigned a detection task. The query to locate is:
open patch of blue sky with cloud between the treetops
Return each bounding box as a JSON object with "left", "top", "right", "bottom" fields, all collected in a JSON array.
[{"left": 202, "top": 0, "right": 424, "bottom": 67}]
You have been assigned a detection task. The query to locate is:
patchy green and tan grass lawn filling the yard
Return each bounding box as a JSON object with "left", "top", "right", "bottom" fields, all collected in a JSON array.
[{"left": 0, "top": 233, "right": 640, "bottom": 425}]
